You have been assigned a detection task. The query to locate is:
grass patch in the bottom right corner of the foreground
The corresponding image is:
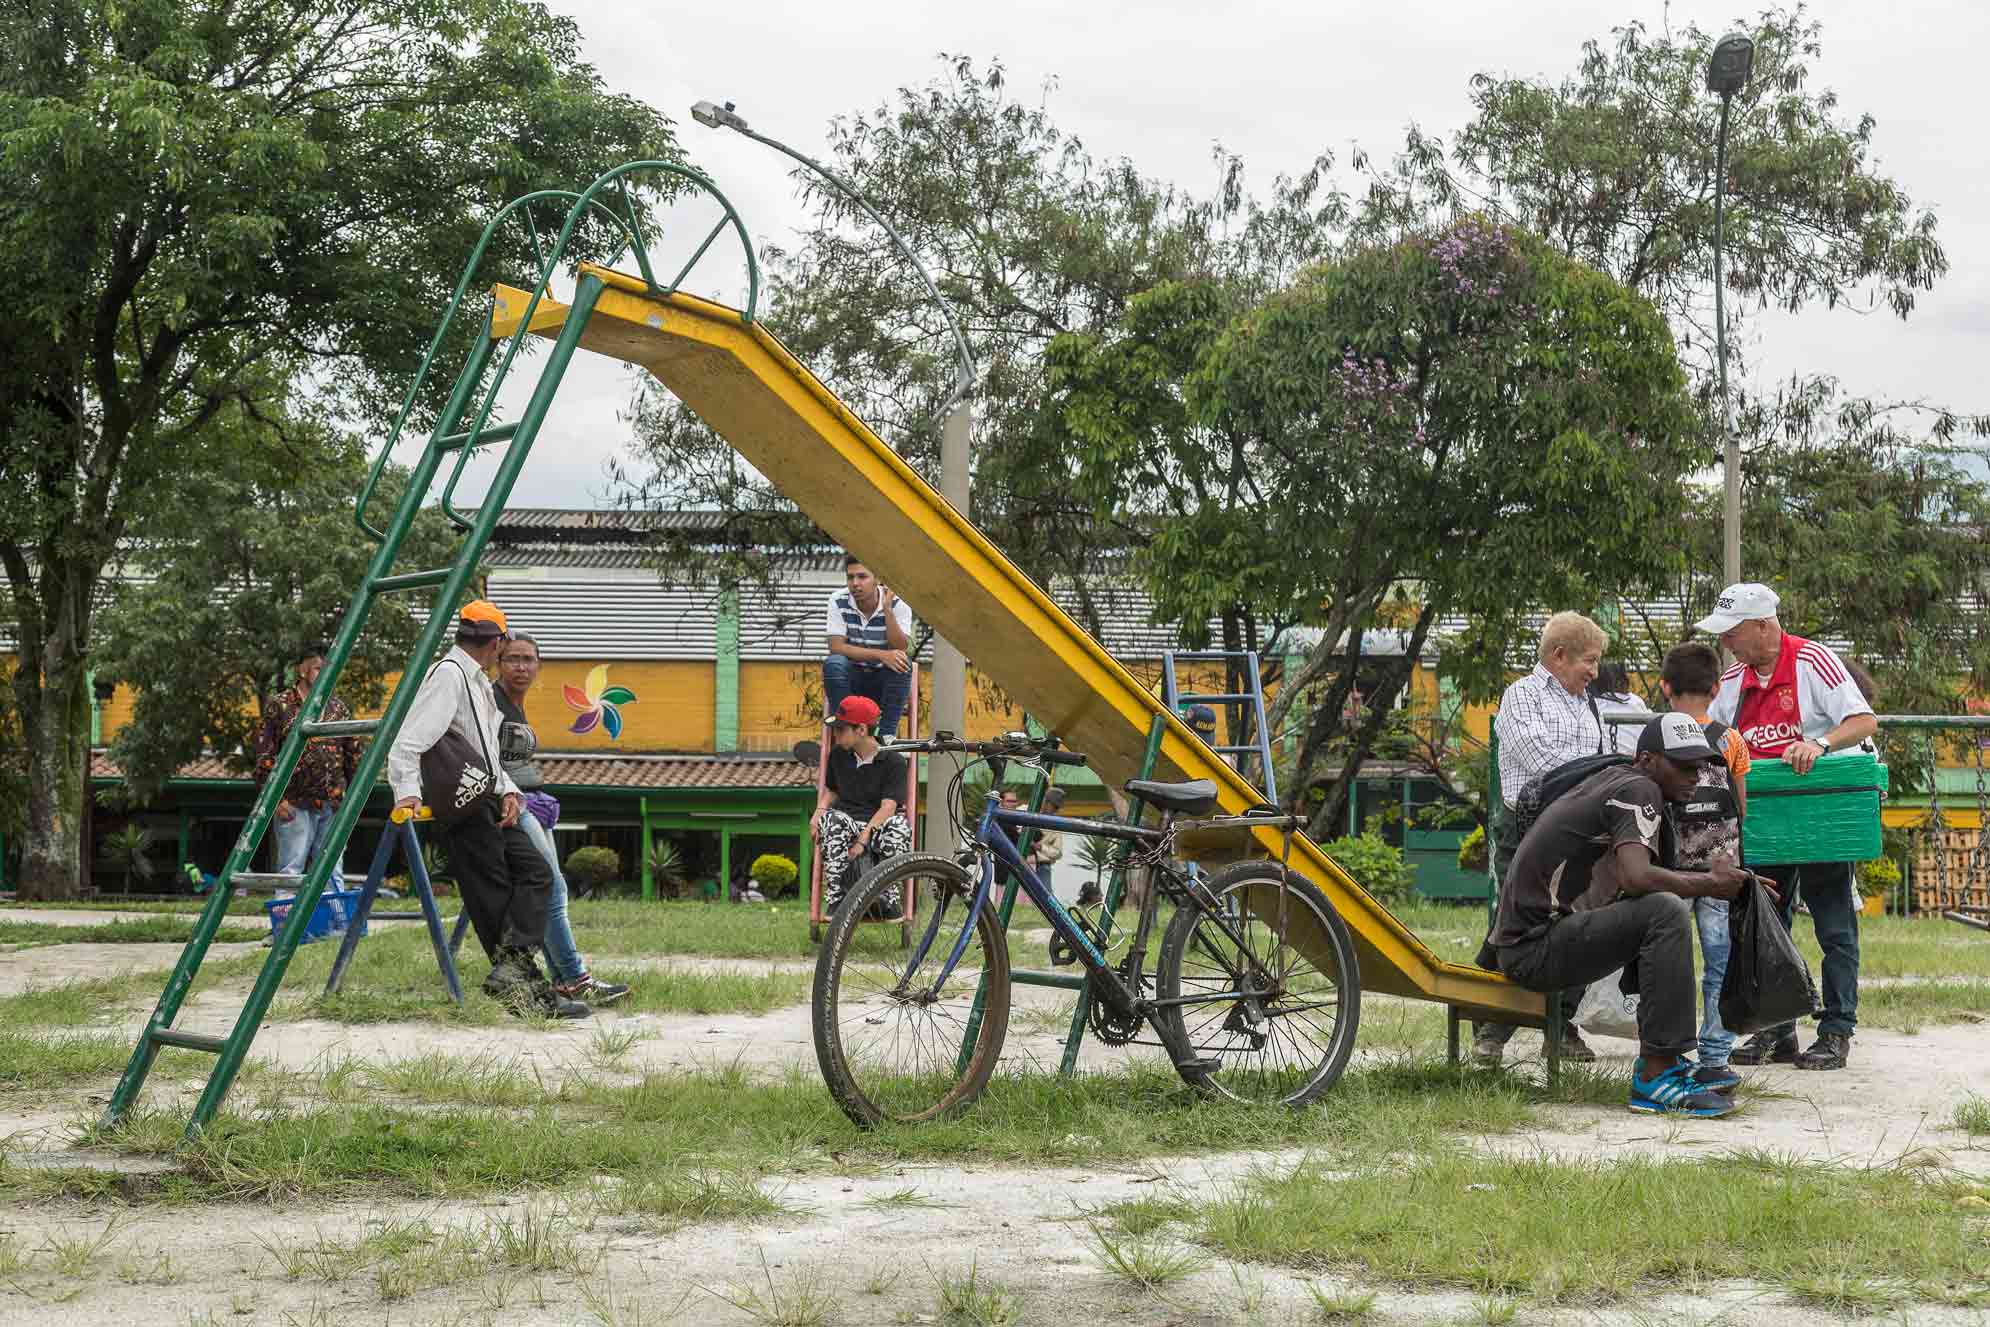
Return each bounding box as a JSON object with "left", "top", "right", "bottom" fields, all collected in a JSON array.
[{"left": 1200, "top": 1148, "right": 1990, "bottom": 1321}]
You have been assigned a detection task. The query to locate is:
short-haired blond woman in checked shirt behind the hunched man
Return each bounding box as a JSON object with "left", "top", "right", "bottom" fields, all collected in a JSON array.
[{"left": 1473, "top": 613, "right": 1608, "bottom": 1064}]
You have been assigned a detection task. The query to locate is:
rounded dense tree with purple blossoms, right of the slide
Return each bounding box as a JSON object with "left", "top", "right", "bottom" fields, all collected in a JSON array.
[{"left": 1170, "top": 215, "right": 1711, "bottom": 828}]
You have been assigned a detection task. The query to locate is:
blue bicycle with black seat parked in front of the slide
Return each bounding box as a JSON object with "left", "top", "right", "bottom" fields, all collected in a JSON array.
[{"left": 810, "top": 732, "right": 1361, "bottom": 1128}]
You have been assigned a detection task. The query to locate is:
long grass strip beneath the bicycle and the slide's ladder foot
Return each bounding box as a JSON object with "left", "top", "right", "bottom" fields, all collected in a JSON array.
[{"left": 54, "top": 1056, "right": 1568, "bottom": 1220}]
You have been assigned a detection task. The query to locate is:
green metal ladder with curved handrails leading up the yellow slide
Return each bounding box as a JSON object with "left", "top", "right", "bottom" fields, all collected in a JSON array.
[{"left": 103, "top": 161, "right": 760, "bottom": 1140}]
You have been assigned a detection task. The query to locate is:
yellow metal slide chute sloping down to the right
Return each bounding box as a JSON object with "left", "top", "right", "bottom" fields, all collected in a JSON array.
[{"left": 492, "top": 267, "right": 1542, "bottom": 1021}]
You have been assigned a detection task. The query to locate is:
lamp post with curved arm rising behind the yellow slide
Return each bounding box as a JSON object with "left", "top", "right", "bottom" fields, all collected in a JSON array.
[{"left": 691, "top": 101, "right": 975, "bottom": 853}]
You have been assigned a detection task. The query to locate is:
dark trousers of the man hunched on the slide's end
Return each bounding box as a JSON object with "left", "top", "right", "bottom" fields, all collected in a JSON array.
[{"left": 1498, "top": 893, "right": 1699, "bottom": 1054}]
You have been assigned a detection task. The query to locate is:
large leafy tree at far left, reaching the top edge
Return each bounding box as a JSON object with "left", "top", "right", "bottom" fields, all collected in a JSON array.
[{"left": 0, "top": 0, "right": 673, "bottom": 897}]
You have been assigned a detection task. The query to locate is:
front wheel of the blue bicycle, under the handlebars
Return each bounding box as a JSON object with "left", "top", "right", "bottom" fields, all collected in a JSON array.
[{"left": 808, "top": 853, "right": 1009, "bottom": 1128}]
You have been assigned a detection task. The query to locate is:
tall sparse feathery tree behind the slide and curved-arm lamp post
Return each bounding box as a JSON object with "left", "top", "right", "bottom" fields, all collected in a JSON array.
[{"left": 625, "top": 56, "right": 1345, "bottom": 631}]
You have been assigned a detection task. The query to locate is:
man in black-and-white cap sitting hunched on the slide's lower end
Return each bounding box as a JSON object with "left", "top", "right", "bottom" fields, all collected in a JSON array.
[{"left": 1493, "top": 712, "right": 1749, "bottom": 1116}]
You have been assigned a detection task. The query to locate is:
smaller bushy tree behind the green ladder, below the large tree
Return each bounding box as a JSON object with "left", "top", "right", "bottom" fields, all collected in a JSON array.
[{"left": 94, "top": 420, "right": 456, "bottom": 802}]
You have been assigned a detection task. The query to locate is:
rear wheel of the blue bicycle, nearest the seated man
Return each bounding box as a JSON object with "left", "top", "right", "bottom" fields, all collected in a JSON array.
[{"left": 1154, "top": 861, "right": 1361, "bottom": 1106}]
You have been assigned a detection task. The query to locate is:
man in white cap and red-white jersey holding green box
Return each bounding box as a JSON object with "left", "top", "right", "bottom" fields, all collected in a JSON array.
[{"left": 1693, "top": 581, "right": 1879, "bottom": 1068}]
